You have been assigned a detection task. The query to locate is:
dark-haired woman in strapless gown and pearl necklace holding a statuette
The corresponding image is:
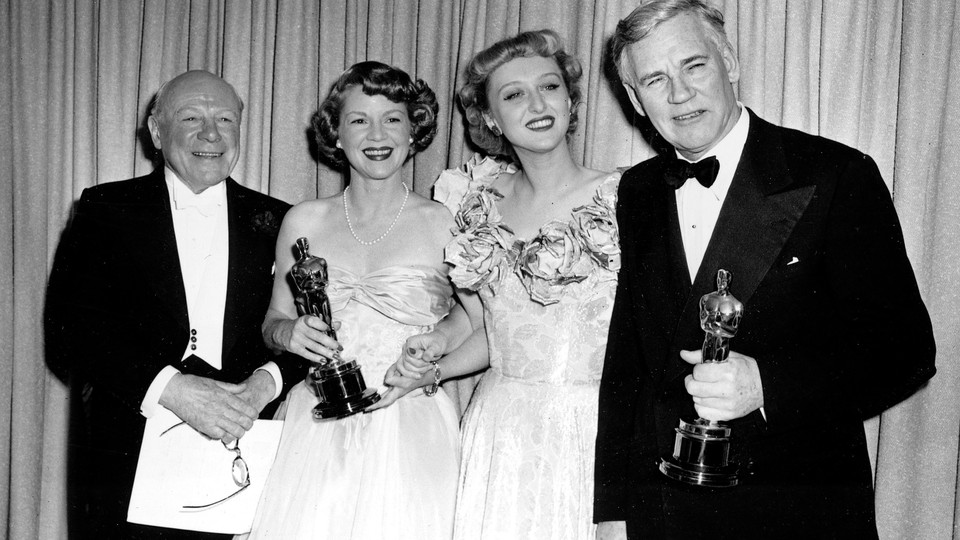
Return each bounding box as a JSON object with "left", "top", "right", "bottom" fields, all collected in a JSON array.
[{"left": 240, "top": 62, "right": 479, "bottom": 539}]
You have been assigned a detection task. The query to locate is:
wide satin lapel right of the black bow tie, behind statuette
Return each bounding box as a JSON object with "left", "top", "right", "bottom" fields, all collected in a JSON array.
[{"left": 673, "top": 111, "right": 815, "bottom": 384}]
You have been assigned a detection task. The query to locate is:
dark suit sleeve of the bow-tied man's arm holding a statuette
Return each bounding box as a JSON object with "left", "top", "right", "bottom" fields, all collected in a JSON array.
[{"left": 760, "top": 153, "right": 936, "bottom": 425}]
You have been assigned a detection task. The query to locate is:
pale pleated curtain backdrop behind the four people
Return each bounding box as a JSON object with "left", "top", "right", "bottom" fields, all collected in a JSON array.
[{"left": 0, "top": 0, "right": 960, "bottom": 539}]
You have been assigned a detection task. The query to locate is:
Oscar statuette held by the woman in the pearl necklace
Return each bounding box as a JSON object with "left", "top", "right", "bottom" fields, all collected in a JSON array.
[{"left": 290, "top": 238, "right": 380, "bottom": 420}]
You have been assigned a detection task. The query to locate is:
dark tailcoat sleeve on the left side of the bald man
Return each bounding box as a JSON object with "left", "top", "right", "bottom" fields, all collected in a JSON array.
[{"left": 45, "top": 189, "right": 172, "bottom": 411}]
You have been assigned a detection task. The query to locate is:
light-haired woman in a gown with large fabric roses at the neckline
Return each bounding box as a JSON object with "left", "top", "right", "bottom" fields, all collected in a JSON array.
[{"left": 399, "top": 30, "right": 620, "bottom": 539}]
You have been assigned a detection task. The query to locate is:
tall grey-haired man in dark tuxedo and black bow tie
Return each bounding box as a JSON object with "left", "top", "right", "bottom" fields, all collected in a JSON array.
[{"left": 595, "top": 0, "right": 935, "bottom": 538}]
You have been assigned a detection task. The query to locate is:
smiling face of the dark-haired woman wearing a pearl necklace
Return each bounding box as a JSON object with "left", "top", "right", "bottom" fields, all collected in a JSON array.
[{"left": 337, "top": 86, "right": 410, "bottom": 180}]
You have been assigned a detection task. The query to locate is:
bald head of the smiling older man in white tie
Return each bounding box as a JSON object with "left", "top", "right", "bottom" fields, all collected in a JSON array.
[{"left": 147, "top": 71, "right": 242, "bottom": 193}]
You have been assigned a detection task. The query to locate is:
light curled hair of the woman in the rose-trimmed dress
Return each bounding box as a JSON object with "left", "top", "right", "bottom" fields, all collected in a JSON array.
[{"left": 459, "top": 29, "right": 583, "bottom": 161}]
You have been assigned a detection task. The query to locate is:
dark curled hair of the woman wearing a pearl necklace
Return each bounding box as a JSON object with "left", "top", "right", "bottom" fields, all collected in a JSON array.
[{"left": 310, "top": 61, "right": 440, "bottom": 169}]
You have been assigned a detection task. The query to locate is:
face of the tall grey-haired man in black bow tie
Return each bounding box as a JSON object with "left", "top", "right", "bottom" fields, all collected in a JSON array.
[{"left": 621, "top": 14, "right": 740, "bottom": 160}]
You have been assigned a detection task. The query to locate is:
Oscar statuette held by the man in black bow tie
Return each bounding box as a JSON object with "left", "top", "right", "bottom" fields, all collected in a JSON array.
[{"left": 660, "top": 269, "right": 743, "bottom": 487}]
